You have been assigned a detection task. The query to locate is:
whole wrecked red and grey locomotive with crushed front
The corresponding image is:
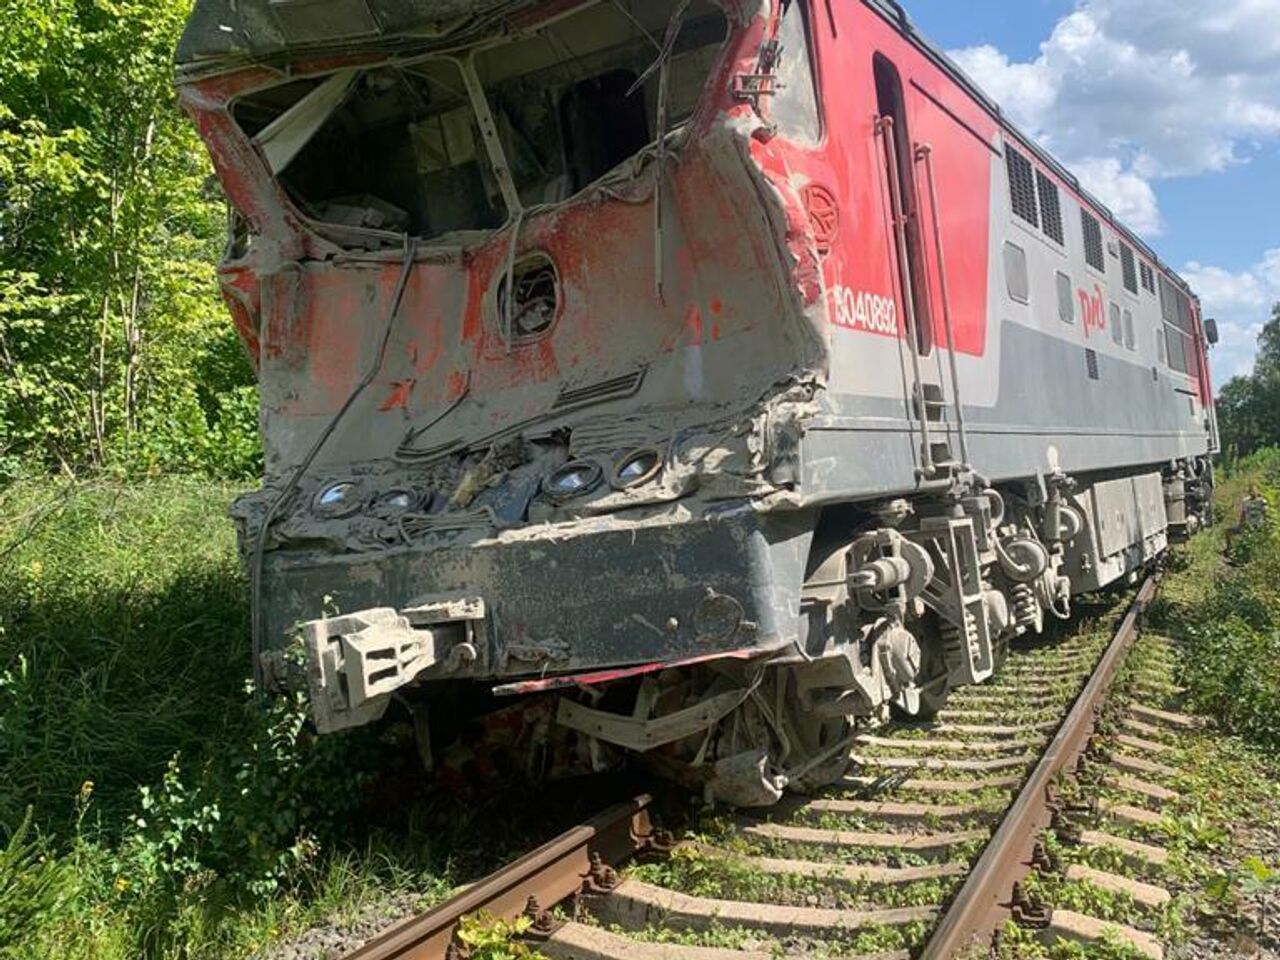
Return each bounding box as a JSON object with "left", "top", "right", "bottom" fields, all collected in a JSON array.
[{"left": 178, "top": 0, "right": 1216, "bottom": 805}]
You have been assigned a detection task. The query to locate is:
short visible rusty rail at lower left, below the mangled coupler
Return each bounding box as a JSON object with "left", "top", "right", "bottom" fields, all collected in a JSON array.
[{"left": 346, "top": 794, "right": 652, "bottom": 960}]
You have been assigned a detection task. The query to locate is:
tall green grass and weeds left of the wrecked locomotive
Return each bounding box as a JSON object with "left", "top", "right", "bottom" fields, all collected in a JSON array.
[{"left": 0, "top": 480, "right": 465, "bottom": 960}]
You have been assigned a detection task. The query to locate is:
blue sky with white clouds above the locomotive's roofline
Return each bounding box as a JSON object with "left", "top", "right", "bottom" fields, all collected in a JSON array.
[{"left": 905, "top": 0, "right": 1280, "bottom": 385}]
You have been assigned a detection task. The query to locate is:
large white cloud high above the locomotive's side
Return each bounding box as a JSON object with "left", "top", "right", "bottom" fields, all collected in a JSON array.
[{"left": 952, "top": 0, "right": 1280, "bottom": 234}]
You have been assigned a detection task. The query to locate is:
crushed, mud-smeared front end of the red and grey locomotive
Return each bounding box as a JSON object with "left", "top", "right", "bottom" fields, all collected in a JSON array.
[{"left": 179, "top": 0, "right": 839, "bottom": 800}]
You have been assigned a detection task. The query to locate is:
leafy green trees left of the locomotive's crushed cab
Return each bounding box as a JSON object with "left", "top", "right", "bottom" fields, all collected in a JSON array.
[{"left": 0, "top": 0, "right": 257, "bottom": 477}]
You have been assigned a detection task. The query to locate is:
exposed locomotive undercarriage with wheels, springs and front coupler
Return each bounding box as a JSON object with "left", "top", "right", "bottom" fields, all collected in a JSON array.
[{"left": 290, "top": 463, "right": 1199, "bottom": 806}]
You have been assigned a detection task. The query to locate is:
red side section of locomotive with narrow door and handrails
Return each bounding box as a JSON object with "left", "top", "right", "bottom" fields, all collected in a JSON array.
[{"left": 815, "top": 3, "right": 998, "bottom": 470}]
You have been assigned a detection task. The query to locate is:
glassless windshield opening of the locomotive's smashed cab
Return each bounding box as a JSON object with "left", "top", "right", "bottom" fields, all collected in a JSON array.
[{"left": 234, "top": 0, "right": 728, "bottom": 248}]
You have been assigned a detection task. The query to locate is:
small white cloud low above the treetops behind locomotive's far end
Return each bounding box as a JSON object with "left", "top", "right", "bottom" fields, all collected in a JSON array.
[{"left": 1180, "top": 248, "right": 1280, "bottom": 387}]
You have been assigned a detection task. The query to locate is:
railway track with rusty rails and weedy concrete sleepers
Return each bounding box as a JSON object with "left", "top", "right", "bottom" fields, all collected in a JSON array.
[{"left": 347, "top": 579, "right": 1194, "bottom": 960}]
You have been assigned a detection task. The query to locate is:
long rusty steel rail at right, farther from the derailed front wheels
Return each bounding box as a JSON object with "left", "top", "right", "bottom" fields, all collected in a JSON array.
[{"left": 922, "top": 575, "right": 1157, "bottom": 960}]
